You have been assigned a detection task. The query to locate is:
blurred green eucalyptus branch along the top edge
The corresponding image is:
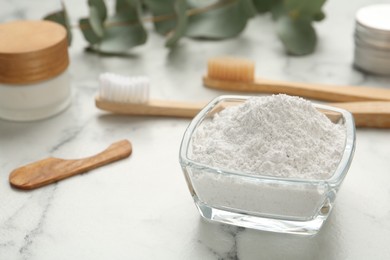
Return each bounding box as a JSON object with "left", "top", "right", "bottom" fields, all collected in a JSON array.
[{"left": 45, "top": 0, "right": 325, "bottom": 55}]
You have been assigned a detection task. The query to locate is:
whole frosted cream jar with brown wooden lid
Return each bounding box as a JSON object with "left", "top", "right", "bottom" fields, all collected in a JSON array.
[{"left": 0, "top": 21, "right": 71, "bottom": 121}]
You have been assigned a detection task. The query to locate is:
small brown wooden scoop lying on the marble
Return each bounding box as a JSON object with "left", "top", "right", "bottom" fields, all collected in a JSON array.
[{"left": 9, "top": 140, "right": 132, "bottom": 190}]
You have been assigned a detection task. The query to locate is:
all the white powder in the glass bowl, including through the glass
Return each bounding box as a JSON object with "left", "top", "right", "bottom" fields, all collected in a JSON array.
[{"left": 191, "top": 95, "right": 346, "bottom": 218}]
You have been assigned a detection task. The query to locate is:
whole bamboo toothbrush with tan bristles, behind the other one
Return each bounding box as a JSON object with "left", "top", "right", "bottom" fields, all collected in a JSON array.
[{"left": 203, "top": 57, "right": 390, "bottom": 102}]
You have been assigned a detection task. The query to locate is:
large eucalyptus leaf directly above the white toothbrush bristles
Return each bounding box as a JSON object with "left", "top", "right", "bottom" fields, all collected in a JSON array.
[{"left": 92, "top": 0, "right": 147, "bottom": 54}]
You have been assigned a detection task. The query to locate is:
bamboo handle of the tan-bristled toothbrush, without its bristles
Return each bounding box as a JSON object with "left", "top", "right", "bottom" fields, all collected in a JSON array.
[{"left": 203, "top": 77, "right": 390, "bottom": 102}]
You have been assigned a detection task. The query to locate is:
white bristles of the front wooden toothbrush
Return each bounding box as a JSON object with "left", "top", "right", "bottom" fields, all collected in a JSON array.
[{"left": 99, "top": 72, "right": 150, "bottom": 103}]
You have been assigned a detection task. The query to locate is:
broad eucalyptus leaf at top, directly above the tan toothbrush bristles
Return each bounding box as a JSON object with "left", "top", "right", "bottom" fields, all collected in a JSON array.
[{"left": 186, "top": 0, "right": 256, "bottom": 39}]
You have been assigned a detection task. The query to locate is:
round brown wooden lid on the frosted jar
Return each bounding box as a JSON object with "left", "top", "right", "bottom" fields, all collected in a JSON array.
[{"left": 0, "top": 21, "right": 69, "bottom": 84}]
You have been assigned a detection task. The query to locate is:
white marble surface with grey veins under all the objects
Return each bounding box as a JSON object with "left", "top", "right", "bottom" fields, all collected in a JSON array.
[{"left": 0, "top": 0, "right": 390, "bottom": 260}]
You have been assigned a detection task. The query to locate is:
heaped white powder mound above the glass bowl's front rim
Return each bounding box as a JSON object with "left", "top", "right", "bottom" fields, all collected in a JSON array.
[{"left": 191, "top": 94, "right": 346, "bottom": 179}]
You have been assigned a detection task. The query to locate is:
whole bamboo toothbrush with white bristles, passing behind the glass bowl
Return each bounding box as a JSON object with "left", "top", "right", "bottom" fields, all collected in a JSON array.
[{"left": 95, "top": 74, "right": 390, "bottom": 128}]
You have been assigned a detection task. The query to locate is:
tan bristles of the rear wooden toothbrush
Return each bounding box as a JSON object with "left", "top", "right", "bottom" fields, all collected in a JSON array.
[{"left": 207, "top": 57, "right": 255, "bottom": 82}]
